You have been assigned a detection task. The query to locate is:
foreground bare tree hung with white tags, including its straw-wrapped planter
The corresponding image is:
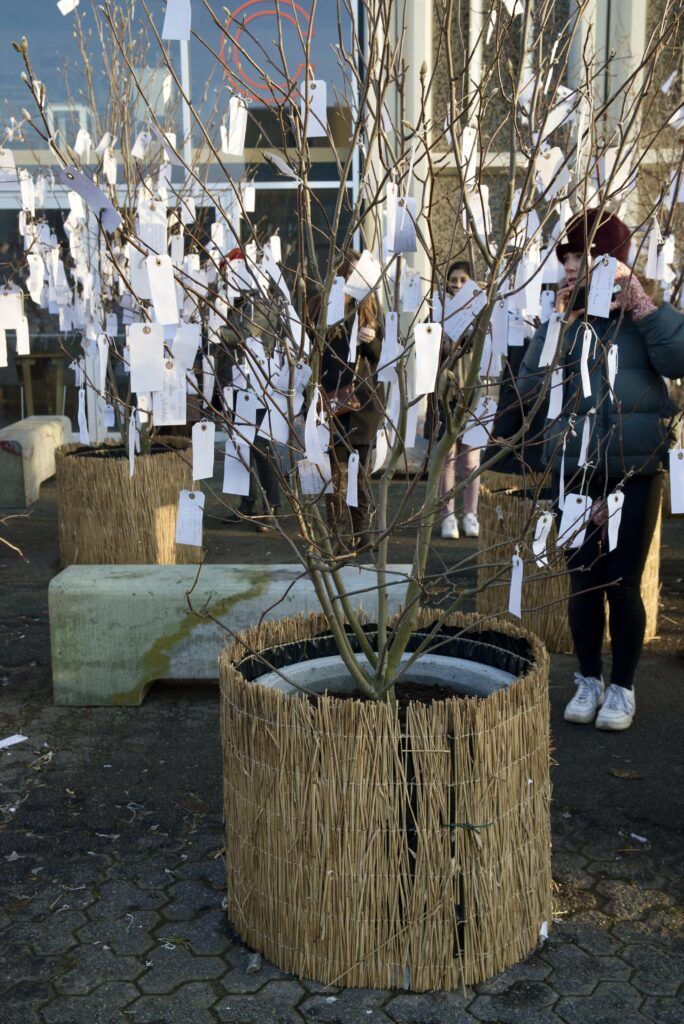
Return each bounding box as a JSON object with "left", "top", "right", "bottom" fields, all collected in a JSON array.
[{"left": 13, "top": 0, "right": 680, "bottom": 989}]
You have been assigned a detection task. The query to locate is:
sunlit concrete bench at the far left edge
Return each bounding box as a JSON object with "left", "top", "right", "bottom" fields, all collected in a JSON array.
[{"left": 0, "top": 416, "right": 72, "bottom": 509}]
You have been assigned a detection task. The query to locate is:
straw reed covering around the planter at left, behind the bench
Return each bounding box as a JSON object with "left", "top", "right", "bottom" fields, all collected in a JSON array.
[{"left": 55, "top": 437, "right": 202, "bottom": 565}]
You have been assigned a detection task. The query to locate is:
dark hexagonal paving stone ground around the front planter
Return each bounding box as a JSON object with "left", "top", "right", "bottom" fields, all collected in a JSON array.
[{"left": 0, "top": 484, "right": 684, "bottom": 1024}]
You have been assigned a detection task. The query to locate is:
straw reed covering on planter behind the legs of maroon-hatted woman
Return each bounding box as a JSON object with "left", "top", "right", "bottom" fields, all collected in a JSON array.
[{"left": 477, "top": 487, "right": 662, "bottom": 653}]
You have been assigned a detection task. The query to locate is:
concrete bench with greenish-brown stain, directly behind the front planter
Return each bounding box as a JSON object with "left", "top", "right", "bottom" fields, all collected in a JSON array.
[{"left": 48, "top": 565, "right": 411, "bottom": 707}]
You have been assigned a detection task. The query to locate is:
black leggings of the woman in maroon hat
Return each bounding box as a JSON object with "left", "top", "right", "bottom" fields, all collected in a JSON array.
[{"left": 556, "top": 475, "right": 661, "bottom": 688}]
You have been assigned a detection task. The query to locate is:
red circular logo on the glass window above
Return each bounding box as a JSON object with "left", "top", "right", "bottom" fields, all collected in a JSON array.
[{"left": 219, "top": 0, "right": 313, "bottom": 105}]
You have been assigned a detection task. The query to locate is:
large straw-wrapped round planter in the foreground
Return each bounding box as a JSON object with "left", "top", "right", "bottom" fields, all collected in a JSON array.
[{"left": 220, "top": 609, "right": 551, "bottom": 991}]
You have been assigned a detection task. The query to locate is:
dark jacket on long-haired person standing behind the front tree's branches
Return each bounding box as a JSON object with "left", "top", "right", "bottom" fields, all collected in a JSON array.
[{"left": 320, "top": 309, "right": 384, "bottom": 447}]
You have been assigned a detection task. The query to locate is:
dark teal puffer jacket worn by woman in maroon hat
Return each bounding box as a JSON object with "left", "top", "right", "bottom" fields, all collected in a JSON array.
[{"left": 517, "top": 302, "right": 684, "bottom": 477}]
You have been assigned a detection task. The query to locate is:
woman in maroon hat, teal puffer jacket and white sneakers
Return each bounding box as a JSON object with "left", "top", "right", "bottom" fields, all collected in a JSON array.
[{"left": 517, "top": 210, "right": 684, "bottom": 730}]
